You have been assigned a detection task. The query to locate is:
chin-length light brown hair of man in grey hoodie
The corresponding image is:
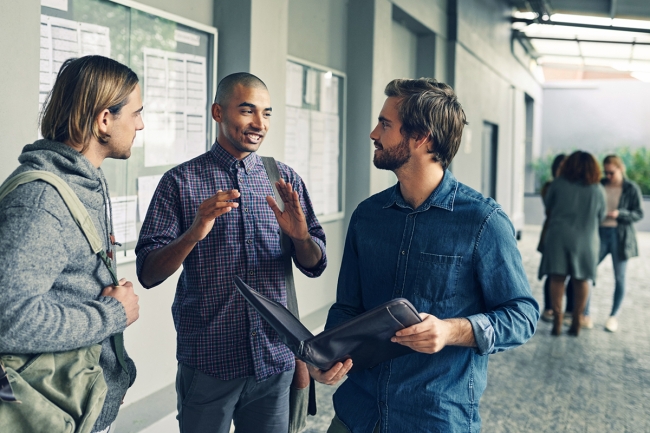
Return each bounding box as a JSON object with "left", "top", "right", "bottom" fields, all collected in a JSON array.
[{"left": 40, "top": 56, "right": 138, "bottom": 152}]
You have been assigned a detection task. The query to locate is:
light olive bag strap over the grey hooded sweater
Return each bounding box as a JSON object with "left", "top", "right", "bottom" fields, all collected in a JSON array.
[{"left": 0, "top": 170, "right": 128, "bottom": 373}]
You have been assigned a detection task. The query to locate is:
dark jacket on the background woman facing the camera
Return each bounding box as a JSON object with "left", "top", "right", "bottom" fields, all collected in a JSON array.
[{"left": 600, "top": 179, "right": 643, "bottom": 260}]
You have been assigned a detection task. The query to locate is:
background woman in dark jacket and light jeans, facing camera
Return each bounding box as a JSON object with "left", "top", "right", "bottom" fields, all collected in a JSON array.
[{"left": 585, "top": 155, "right": 643, "bottom": 332}]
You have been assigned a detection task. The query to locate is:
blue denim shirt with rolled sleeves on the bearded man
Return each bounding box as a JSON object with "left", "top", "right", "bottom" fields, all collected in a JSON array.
[{"left": 326, "top": 171, "right": 539, "bottom": 433}]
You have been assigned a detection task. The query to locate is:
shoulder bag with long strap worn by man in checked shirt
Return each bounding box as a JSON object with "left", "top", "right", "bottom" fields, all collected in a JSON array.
[{"left": 262, "top": 156, "right": 317, "bottom": 433}]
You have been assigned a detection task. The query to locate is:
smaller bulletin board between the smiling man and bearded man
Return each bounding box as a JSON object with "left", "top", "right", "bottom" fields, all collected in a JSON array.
[{"left": 284, "top": 57, "right": 347, "bottom": 222}]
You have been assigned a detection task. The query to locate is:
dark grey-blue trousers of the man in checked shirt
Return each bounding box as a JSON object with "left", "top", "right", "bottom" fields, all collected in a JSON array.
[{"left": 176, "top": 363, "right": 293, "bottom": 433}]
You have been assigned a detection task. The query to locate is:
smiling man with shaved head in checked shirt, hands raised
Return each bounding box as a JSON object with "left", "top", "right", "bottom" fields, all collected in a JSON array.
[{"left": 136, "top": 72, "right": 327, "bottom": 433}]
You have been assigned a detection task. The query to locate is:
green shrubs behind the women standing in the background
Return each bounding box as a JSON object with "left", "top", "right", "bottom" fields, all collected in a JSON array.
[{"left": 531, "top": 147, "right": 650, "bottom": 195}]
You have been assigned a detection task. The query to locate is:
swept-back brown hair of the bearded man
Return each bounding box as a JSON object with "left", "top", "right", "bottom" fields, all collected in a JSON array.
[{"left": 384, "top": 78, "right": 467, "bottom": 169}]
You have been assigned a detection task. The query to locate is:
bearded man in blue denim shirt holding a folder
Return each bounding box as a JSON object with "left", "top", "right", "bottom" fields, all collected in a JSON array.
[{"left": 310, "top": 78, "right": 539, "bottom": 433}]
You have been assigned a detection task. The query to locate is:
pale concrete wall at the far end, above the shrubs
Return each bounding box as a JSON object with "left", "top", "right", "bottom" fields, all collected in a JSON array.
[{"left": 541, "top": 80, "right": 650, "bottom": 154}]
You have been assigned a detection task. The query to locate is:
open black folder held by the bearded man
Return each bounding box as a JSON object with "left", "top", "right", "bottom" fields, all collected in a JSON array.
[{"left": 235, "top": 276, "right": 422, "bottom": 373}]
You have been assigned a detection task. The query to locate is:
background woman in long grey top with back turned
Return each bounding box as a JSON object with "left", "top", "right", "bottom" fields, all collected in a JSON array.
[{"left": 539, "top": 151, "right": 606, "bottom": 336}]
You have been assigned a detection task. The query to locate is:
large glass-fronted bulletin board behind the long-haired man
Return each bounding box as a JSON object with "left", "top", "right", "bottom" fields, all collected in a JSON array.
[{"left": 39, "top": 0, "right": 217, "bottom": 262}]
